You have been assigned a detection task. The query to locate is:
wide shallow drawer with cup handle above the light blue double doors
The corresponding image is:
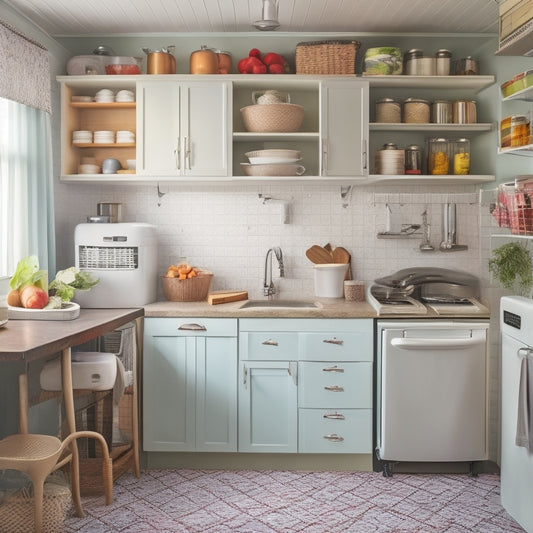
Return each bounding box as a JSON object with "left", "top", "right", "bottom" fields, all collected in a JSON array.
[{"left": 144, "top": 317, "right": 237, "bottom": 337}]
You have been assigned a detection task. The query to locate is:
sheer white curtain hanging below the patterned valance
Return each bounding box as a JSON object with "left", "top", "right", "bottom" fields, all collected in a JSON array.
[{"left": 0, "top": 98, "right": 55, "bottom": 276}]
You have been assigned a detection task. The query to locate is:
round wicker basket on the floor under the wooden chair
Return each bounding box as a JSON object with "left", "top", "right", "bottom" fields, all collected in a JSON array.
[{"left": 0, "top": 472, "right": 72, "bottom": 533}]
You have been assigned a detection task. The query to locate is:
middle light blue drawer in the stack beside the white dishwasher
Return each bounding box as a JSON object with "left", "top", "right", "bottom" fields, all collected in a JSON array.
[{"left": 298, "top": 362, "right": 372, "bottom": 409}]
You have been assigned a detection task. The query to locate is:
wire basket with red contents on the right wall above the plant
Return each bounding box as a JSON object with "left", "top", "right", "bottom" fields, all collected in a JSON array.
[{"left": 491, "top": 177, "right": 533, "bottom": 235}]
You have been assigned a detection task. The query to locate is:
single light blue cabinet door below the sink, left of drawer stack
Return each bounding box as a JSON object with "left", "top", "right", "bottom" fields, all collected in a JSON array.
[{"left": 239, "top": 360, "right": 298, "bottom": 453}]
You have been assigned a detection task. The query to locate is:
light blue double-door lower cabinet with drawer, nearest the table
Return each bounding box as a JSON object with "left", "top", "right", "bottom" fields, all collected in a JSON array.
[{"left": 143, "top": 318, "right": 237, "bottom": 452}]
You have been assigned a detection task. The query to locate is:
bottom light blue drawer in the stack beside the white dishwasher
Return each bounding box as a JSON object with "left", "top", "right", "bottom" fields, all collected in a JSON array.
[{"left": 298, "top": 409, "right": 372, "bottom": 453}]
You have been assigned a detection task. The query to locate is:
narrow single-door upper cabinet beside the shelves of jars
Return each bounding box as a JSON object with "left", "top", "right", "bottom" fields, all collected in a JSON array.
[{"left": 320, "top": 81, "right": 368, "bottom": 177}]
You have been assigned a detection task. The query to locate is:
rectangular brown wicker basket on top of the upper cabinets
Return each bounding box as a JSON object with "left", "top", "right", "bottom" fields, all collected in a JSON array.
[{"left": 296, "top": 41, "right": 361, "bottom": 75}]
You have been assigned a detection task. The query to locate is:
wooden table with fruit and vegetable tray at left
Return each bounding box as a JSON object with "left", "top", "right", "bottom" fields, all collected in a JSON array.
[{"left": 0, "top": 308, "right": 144, "bottom": 500}]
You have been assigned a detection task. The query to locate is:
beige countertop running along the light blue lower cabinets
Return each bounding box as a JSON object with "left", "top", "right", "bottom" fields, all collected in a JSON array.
[{"left": 144, "top": 298, "right": 490, "bottom": 320}]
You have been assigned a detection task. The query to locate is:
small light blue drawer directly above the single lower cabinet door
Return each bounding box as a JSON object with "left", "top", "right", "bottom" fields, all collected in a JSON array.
[{"left": 239, "top": 331, "right": 298, "bottom": 361}]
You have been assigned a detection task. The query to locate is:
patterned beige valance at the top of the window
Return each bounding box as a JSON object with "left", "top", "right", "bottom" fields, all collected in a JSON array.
[{"left": 0, "top": 20, "right": 51, "bottom": 113}]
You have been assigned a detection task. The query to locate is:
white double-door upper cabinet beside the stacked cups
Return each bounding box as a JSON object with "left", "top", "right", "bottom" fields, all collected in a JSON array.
[{"left": 137, "top": 80, "right": 231, "bottom": 177}]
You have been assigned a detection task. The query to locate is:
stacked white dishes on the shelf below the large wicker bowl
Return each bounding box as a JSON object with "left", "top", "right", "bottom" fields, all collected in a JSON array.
[{"left": 241, "top": 149, "right": 305, "bottom": 176}]
